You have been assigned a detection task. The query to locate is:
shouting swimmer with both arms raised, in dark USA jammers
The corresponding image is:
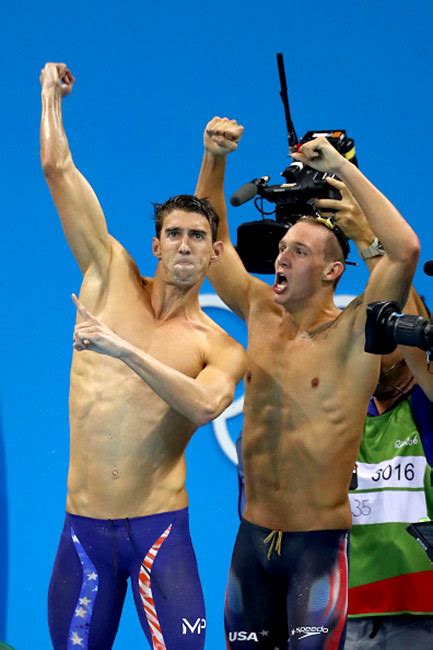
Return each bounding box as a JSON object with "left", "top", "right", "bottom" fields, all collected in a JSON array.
[{"left": 197, "top": 118, "right": 419, "bottom": 650}]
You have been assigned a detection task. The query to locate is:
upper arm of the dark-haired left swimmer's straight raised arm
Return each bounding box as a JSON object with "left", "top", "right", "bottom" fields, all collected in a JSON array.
[{"left": 47, "top": 164, "right": 110, "bottom": 274}]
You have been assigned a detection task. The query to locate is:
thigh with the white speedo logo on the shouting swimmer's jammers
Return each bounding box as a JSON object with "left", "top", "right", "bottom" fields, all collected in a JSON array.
[{"left": 287, "top": 531, "right": 348, "bottom": 650}]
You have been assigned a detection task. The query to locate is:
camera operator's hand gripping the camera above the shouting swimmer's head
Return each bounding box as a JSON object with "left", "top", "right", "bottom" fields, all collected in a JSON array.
[{"left": 314, "top": 177, "right": 374, "bottom": 248}]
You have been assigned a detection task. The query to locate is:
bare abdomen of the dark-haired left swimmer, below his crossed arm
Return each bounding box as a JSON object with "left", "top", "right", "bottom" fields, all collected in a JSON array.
[{"left": 67, "top": 353, "right": 194, "bottom": 519}]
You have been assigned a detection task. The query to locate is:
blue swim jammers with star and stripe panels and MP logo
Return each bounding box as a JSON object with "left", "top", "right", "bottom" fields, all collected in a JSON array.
[{"left": 48, "top": 508, "right": 206, "bottom": 650}]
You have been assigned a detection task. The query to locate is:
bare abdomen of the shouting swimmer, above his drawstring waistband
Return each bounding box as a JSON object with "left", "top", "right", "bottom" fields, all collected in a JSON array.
[{"left": 243, "top": 388, "right": 367, "bottom": 531}]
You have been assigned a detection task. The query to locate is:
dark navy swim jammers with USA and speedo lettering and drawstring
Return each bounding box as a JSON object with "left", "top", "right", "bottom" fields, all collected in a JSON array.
[{"left": 225, "top": 519, "right": 348, "bottom": 650}]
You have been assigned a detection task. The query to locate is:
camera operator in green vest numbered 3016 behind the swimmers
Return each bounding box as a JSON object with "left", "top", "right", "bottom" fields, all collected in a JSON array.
[{"left": 316, "top": 185, "right": 433, "bottom": 650}]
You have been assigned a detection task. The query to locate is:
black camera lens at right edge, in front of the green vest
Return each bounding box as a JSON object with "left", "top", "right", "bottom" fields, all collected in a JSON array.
[{"left": 364, "top": 301, "right": 433, "bottom": 354}]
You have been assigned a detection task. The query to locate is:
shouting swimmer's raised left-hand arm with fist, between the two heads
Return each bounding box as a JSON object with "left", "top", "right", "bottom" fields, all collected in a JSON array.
[{"left": 195, "top": 117, "right": 254, "bottom": 319}]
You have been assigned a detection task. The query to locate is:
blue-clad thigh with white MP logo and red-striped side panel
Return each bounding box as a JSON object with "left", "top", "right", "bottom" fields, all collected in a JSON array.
[{"left": 131, "top": 511, "right": 206, "bottom": 650}]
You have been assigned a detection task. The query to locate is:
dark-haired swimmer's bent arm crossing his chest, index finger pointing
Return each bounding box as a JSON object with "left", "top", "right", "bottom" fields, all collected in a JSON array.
[{"left": 72, "top": 295, "right": 246, "bottom": 427}]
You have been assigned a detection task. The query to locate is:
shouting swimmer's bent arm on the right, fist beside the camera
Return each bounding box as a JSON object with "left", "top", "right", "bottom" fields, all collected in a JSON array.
[{"left": 292, "top": 138, "right": 419, "bottom": 308}]
